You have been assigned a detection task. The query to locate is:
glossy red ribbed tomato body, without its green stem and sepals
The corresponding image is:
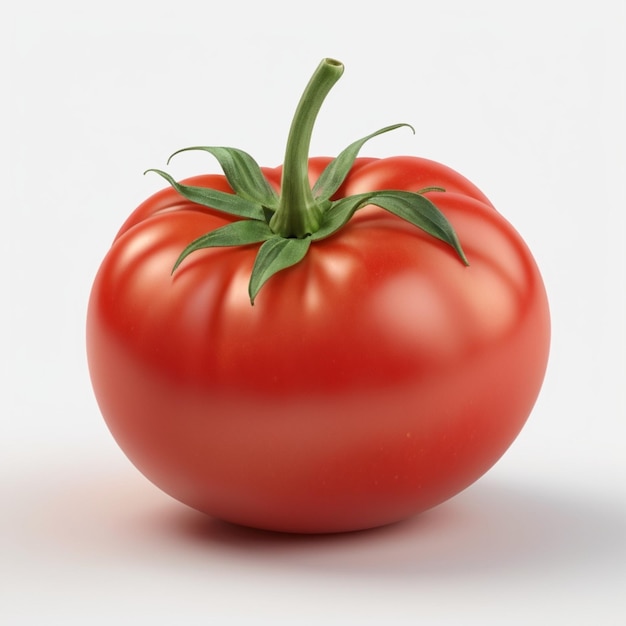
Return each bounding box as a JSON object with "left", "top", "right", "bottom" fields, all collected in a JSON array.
[{"left": 87, "top": 157, "right": 550, "bottom": 533}]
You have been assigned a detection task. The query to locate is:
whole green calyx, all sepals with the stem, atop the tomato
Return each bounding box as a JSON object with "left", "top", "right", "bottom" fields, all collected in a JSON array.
[{"left": 147, "top": 59, "right": 468, "bottom": 304}]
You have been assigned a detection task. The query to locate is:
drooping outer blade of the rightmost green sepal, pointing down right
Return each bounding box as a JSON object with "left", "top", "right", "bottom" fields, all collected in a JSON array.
[{"left": 368, "top": 190, "right": 469, "bottom": 265}]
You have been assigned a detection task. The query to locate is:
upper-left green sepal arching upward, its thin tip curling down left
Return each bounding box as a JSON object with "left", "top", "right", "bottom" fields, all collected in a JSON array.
[{"left": 167, "top": 146, "right": 279, "bottom": 209}]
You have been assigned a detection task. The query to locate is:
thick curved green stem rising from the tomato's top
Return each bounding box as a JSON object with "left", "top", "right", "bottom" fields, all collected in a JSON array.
[{"left": 270, "top": 59, "right": 343, "bottom": 239}]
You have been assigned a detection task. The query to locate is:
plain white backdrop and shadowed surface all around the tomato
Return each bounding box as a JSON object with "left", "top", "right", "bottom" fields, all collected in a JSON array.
[{"left": 0, "top": 0, "right": 626, "bottom": 626}]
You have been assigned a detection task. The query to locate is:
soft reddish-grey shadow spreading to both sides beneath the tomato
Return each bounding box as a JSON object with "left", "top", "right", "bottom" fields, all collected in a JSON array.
[{"left": 18, "top": 461, "right": 626, "bottom": 581}]
